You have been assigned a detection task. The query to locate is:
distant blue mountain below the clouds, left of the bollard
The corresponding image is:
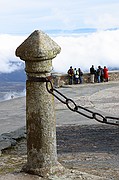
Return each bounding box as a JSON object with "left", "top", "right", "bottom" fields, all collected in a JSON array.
[{"left": 0, "top": 70, "right": 26, "bottom": 82}]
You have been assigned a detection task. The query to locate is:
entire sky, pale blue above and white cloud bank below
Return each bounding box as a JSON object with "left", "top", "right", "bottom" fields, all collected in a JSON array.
[{"left": 0, "top": 0, "right": 119, "bottom": 73}]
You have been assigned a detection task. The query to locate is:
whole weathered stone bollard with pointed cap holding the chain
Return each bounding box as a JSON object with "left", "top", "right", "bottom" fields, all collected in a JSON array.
[{"left": 16, "top": 30, "right": 63, "bottom": 177}]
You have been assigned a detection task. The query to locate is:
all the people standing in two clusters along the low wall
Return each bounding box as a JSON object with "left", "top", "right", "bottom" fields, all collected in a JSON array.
[{"left": 67, "top": 65, "right": 109, "bottom": 85}]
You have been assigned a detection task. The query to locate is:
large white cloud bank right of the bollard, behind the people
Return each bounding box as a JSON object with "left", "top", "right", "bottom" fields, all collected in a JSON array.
[{"left": 53, "top": 30, "right": 119, "bottom": 72}]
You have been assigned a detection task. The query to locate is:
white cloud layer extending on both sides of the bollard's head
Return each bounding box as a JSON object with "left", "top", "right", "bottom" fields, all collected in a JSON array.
[{"left": 0, "top": 30, "right": 119, "bottom": 73}]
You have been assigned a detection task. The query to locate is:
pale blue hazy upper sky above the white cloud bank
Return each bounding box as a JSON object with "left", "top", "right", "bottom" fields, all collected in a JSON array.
[{"left": 0, "top": 0, "right": 119, "bottom": 34}]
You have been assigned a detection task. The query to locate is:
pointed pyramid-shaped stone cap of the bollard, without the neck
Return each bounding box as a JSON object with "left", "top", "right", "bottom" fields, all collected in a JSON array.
[{"left": 15, "top": 30, "right": 61, "bottom": 61}]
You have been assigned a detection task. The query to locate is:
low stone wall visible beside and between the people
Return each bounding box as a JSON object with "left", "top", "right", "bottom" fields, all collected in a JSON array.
[{"left": 52, "top": 71, "right": 119, "bottom": 87}]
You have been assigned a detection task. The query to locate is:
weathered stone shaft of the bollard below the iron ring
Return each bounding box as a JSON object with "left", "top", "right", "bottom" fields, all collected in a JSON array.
[{"left": 25, "top": 81, "right": 60, "bottom": 175}]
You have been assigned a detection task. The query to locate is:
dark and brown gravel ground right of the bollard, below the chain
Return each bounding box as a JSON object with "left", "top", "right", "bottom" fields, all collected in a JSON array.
[{"left": 57, "top": 125, "right": 119, "bottom": 180}]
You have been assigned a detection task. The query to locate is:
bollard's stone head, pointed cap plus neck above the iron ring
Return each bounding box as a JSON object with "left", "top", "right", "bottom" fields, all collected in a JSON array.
[{"left": 16, "top": 30, "right": 61, "bottom": 76}]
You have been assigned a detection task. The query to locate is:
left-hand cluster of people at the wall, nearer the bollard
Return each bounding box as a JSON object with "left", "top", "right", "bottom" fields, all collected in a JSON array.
[{"left": 67, "top": 66, "right": 83, "bottom": 85}]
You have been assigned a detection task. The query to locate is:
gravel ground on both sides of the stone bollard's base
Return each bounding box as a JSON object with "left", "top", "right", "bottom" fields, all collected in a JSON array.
[{"left": 0, "top": 124, "right": 119, "bottom": 180}]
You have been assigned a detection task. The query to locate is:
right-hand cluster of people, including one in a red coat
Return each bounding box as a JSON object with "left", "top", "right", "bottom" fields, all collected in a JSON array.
[{"left": 90, "top": 65, "right": 109, "bottom": 83}]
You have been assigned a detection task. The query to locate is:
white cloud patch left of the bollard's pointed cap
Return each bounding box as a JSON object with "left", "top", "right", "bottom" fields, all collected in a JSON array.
[{"left": 0, "top": 34, "right": 25, "bottom": 73}]
